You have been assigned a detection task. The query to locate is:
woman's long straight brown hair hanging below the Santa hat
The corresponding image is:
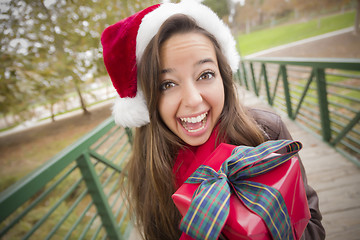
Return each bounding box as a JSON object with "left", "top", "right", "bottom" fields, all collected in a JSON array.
[{"left": 127, "top": 14, "right": 264, "bottom": 239}]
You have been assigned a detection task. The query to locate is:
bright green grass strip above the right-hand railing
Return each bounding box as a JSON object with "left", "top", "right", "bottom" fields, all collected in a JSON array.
[{"left": 237, "top": 11, "right": 355, "bottom": 56}]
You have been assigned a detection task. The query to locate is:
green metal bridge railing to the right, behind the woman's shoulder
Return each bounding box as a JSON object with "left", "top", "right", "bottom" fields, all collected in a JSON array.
[{"left": 237, "top": 58, "right": 360, "bottom": 167}]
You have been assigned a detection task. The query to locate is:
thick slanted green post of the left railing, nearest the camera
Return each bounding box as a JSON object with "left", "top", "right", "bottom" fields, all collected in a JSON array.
[{"left": 76, "top": 153, "right": 121, "bottom": 239}]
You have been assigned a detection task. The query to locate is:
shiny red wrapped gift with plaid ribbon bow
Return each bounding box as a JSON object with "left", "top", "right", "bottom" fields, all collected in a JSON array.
[{"left": 172, "top": 140, "right": 310, "bottom": 239}]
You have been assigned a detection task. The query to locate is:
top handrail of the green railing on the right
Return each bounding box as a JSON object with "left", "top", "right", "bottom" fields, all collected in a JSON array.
[{"left": 241, "top": 57, "right": 360, "bottom": 70}]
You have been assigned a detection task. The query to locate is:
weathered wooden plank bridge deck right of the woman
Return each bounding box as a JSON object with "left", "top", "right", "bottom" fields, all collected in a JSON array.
[{"left": 240, "top": 88, "right": 360, "bottom": 240}]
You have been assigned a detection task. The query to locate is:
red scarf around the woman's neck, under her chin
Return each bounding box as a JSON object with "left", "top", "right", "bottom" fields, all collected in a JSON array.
[{"left": 173, "top": 126, "right": 220, "bottom": 189}]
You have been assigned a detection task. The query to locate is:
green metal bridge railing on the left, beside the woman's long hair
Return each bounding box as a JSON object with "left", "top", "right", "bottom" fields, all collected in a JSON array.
[{"left": 0, "top": 118, "right": 132, "bottom": 239}]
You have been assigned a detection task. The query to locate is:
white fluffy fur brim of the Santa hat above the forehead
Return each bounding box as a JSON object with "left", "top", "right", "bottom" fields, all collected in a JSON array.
[{"left": 136, "top": 1, "right": 240, "bottom": 72}]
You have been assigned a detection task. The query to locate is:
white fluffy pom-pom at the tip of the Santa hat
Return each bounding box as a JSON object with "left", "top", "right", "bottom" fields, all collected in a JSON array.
[{"left": 112, "top": 89, "right": 150, "bottom": 128}]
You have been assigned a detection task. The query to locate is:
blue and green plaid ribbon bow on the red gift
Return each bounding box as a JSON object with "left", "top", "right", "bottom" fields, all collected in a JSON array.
[{"left": 180, "top": 140, "right": 302, "bottom": 239}]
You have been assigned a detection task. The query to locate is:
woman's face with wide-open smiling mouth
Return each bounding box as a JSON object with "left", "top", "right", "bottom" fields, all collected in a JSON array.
[{"left": 158, "top": 33, "right": 224, "bottom": 146}]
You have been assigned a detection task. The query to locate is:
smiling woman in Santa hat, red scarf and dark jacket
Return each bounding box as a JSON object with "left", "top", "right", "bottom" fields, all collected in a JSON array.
[{"left": 102, "top": 2, "right": 325, "bottom": 239}]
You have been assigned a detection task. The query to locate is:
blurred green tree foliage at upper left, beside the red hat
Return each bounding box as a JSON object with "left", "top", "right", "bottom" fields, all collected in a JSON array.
[{"left": 0, "top": 0, "right": 155, "bottom": 122}]
